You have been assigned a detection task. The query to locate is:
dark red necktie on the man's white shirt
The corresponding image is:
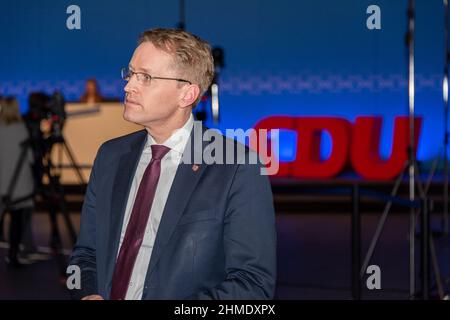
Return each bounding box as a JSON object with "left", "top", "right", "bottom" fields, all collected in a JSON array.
[{"left": 110, "top": 145, "right": 170, "bottom": 300}]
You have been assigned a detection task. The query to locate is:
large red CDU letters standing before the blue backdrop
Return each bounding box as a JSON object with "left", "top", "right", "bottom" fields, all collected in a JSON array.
[{"left": 252, "top": 116, "right": 422, "bottom": 180}]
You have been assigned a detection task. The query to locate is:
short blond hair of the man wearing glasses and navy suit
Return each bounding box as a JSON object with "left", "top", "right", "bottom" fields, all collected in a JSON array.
[{"left": 138, "top": 28, "right": 214, "bottom": 105}]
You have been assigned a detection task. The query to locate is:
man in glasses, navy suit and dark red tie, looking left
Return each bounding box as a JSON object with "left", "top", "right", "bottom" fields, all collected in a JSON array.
[{"left": 70, "top": 29, "right": 276, "bottom": 300}]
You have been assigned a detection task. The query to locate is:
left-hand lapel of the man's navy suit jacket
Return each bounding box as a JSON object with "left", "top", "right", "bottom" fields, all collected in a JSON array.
[{"left": 106, "top": 130, "right": 147, "bottom": 292}]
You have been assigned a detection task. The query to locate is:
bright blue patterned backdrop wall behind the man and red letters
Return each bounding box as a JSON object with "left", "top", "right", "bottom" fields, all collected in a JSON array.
[{"left": 0, "top": 0, "right": 444, "bottom": 168}]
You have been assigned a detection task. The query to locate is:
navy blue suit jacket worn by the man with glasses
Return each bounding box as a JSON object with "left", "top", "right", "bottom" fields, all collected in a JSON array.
[{"left": 70, "top": 125, "right": 276, "bottom": 299}]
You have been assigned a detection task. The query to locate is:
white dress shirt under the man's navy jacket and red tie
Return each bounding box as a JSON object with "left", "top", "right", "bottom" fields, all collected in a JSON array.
[{"left": 119, "top": 114, "right": 194, "bottom": 300}]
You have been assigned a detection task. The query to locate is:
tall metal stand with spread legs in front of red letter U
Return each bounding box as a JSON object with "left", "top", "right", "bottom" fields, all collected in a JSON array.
[{"left": 360, "top": 0, "right": 444, "bottom": 299}]
